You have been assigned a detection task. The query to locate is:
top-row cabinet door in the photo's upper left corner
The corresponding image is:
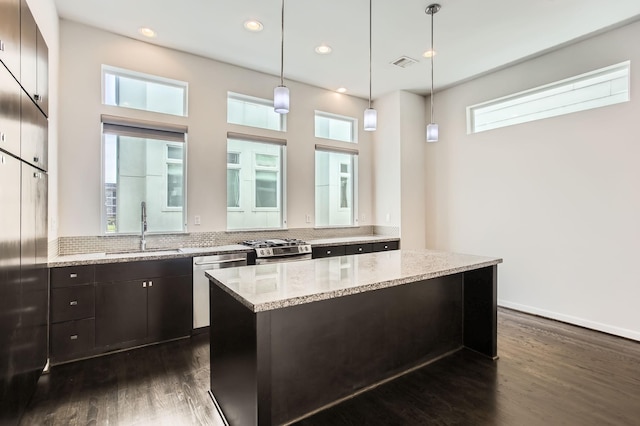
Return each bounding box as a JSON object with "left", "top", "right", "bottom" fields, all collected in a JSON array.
[{"left": 0, "top": 0, "right": 20, "bottom": 78}]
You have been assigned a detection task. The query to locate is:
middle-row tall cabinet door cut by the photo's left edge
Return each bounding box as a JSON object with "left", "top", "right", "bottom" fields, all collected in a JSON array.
[{"left": 0, "top": 62, "right": 22, "bottom": 157}]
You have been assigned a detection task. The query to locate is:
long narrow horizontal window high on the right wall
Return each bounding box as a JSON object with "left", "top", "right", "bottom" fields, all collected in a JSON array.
[{"left": 467, "top": 61, "right": 630, "bottom": 133}]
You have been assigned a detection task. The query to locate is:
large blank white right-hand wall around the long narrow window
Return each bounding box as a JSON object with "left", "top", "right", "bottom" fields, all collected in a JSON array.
[{"left": 426, "top": 23, "right": 640, "bottom": 340}]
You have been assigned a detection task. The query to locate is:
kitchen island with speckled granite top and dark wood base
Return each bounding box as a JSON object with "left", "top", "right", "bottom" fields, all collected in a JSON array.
[{"left": 206, "top": 250, "right": 502, "bottom": 425}]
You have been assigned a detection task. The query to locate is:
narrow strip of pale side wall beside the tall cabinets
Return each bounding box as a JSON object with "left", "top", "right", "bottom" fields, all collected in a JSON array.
[{"left": 27, "top": 0, "right": 60, "bottom": 245}]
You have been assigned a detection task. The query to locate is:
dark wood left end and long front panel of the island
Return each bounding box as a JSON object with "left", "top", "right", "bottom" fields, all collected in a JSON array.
[{"left": 211, "top": 274, "right": 463, "bottom": 425}]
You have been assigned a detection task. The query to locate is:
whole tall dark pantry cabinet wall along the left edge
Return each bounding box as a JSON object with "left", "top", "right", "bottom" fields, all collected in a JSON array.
[{"left": 0, "top": 0, "right": 49, "bottom": 425}]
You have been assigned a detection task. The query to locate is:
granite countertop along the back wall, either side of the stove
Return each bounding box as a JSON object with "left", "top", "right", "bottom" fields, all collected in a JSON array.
[{"left": 47, "top": 235, "right": 400, "bottom": 268}]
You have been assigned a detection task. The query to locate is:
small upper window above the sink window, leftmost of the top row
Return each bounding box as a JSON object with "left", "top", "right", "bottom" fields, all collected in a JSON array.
[{"left": 102, "top": 65, "right": 188, "bottom": 116}]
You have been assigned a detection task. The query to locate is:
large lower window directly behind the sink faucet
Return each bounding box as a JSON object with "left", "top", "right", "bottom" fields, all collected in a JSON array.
[{"left": 102, "top": 115, "right": 187, "bottom": 234}]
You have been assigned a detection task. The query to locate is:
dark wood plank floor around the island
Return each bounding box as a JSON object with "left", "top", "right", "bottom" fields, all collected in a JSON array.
[{"left": 21, "top": 309, "right": 640, "bottom": 426}]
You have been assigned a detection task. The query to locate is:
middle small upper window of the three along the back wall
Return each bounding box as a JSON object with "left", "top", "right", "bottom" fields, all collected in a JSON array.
[{"left": 227, "top": 92, "right": 286, "bottom": 132}]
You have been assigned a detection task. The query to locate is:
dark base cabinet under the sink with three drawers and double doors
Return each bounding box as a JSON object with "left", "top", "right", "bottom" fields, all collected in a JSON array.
[{"left": 50, "top": 257, "right": 193, "bottom": 363}]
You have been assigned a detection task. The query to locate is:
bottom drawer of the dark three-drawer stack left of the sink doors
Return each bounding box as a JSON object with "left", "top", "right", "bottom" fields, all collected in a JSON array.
[{"left": 51, "top": 318, "right": 95, "bottom": 361}]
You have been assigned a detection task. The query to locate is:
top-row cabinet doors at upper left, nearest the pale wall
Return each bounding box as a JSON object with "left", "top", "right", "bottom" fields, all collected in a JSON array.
[{"left": 19, "top": 0, "right": 49, "bottom": 115}]
